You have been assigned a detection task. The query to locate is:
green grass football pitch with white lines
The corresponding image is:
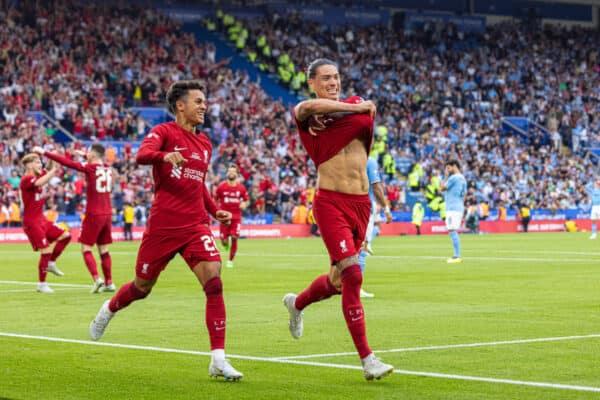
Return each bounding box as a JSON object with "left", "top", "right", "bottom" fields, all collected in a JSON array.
[{"left": 0, "top": 233, "right": 600, "bottom": 400}]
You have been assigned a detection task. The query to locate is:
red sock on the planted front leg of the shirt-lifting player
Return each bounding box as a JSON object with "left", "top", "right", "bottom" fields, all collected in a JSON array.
[{"left": 342, "top": 264, "right": 371, "bottom": 359}]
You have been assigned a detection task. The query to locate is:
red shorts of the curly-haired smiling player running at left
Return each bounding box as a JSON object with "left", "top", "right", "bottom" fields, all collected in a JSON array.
[{"left": 135, "top": 225, "right": 221, "bottom": 279}]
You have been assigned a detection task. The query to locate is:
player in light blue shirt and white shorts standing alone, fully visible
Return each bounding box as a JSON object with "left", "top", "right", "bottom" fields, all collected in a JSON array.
[{"left": 442, "top": 159, "right": 467, "bottom": 264}]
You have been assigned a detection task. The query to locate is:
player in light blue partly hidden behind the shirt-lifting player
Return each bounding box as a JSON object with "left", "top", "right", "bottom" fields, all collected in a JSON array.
[{"left": 358, "top": 157, "right": 392, "bottom": 297}]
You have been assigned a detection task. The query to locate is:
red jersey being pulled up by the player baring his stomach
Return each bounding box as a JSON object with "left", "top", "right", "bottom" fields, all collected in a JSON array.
[{"left": 294, "top": 96, "right": 373, "bottom": 167}]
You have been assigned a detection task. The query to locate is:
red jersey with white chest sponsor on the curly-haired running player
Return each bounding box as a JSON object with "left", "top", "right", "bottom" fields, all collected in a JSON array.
[{"left": 136, "top": 122, "right": 216, "bottom": 232}]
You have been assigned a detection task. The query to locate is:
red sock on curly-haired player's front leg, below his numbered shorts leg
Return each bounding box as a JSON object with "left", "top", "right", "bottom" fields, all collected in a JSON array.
[{"left": 204, "top": 277, "right": 226, "bottom": 350}]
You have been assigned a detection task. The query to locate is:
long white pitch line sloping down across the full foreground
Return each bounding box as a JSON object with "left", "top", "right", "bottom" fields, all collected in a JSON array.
[{"left": 0, "top": 332, "right": 600, "bottom": 392}]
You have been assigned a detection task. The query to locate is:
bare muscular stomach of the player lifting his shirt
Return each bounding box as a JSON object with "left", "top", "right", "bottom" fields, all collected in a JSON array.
[{"left": 317, "top": 139, "right": 369, "bottom": 194}]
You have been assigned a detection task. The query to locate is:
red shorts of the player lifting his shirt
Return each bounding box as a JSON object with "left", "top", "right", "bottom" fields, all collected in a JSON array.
[{"left": 313, "top": 189, "right": 371, "bottom": 265}]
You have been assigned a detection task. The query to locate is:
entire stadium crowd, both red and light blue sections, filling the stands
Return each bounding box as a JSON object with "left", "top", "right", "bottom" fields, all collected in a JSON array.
[{"left": 0, "top": 2, "right": 600, "bottom": 224}]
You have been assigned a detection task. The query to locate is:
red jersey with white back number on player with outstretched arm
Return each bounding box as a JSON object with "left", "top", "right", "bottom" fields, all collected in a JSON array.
[{"left": 44, "top": 152, "right": 112, "bottom": 215}]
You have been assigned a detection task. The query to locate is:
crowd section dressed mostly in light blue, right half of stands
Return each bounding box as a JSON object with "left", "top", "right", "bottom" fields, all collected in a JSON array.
[{"left": 218, "top": 10, "right": 600, "bottom": 209}]
